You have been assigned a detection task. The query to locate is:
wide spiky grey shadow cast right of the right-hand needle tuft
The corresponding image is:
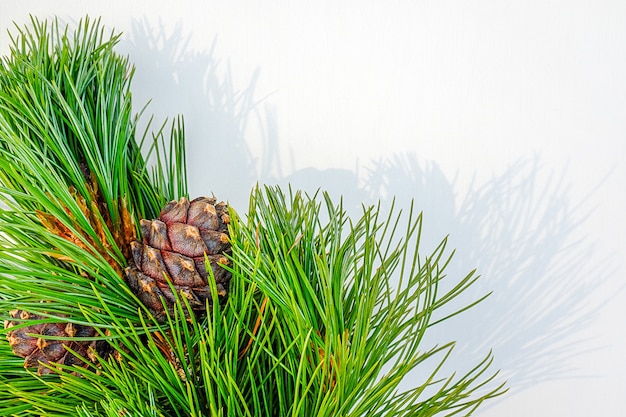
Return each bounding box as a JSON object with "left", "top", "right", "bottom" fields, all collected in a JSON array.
[{"left": 278, "top": 155, "right": 610, "bottom": 392}]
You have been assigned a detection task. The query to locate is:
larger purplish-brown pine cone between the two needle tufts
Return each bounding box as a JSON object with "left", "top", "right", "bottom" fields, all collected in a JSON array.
[{"left": 126, "top": 197, "right": 230, "bottom": 318}]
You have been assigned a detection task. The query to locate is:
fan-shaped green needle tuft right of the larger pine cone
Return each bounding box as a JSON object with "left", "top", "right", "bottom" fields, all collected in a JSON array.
[{"left": 227, "top": 188, "right": 502, "bottom": 416}]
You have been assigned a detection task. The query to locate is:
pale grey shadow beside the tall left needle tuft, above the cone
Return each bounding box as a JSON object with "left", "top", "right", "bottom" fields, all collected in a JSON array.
[{"left": 122, "top": 19, "right": 259, "bottom": 205}]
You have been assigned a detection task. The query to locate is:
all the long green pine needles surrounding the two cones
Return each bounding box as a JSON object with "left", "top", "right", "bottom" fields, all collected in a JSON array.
[{"left": 0, "top": 14, "right": 505, "bottom": 417}]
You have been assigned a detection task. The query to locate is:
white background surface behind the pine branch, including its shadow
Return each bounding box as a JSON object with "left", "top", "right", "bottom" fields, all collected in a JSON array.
[{"left": 0, "top": 0, "right": 626, "bottom": 417}]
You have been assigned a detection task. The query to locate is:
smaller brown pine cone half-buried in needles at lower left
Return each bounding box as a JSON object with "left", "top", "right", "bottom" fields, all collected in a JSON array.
[{"left": 4, "top": 310, "right": 105, "bottom": 375}]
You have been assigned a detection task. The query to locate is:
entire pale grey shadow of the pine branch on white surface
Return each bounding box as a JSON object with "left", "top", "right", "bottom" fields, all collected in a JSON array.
[{"left": 123, "top": 20, "right": 608, "bottom": 406}]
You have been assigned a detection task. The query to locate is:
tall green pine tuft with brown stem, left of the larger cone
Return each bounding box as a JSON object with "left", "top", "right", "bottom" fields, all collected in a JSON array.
[{"left": 0, "top": 18, "right": 186, "bottom": 415}]
